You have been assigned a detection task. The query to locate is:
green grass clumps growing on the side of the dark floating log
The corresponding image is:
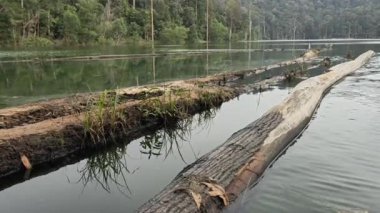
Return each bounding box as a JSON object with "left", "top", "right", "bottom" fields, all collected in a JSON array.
[{"left": 83, "top": 88, "right": 232, "bottom": 147}]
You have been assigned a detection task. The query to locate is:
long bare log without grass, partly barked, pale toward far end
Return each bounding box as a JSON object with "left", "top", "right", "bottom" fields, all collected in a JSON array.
[{"left": 139, "top": 51, "right": 374, "bottom": 212}]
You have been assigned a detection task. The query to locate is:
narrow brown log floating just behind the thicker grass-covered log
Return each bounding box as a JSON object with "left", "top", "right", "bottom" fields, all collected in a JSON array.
[{"left": 0, "top": 51, "right": 320, "bottom": 130}]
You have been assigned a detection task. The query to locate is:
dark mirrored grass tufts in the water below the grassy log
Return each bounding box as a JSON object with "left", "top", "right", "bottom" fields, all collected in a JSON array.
[{"left": 77, "top": 108, "right": 217, "bottom": 194}]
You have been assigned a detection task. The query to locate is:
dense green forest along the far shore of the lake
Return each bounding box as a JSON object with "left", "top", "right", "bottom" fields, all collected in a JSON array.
[{"left": 0, "top": 0, "right": 380, "bottom": 46}]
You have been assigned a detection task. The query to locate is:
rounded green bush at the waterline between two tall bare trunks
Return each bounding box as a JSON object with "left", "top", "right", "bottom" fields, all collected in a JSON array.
[{"left": 160, "top": 24, "right": 189, "bottom": 44}]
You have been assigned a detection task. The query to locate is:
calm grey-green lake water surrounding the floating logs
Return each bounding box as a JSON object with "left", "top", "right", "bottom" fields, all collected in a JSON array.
[{"left": 0, "top": 42, "right": 380, "bottom": 213}]
